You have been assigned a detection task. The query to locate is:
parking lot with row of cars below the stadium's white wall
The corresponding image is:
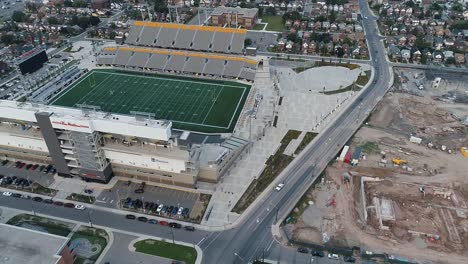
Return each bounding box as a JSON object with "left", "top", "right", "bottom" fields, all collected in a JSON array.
[{"left": 96, "top": 181, "right": 199, "bottom": 210}]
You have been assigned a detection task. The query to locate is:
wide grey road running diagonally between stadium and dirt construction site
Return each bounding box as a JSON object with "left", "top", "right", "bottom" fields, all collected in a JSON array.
[{"left": 202, "top": 0, "right": 391, "bottom": 263}]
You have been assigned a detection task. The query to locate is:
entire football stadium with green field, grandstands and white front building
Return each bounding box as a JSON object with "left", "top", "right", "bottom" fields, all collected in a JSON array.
[{"left": 0, "top": 21, "right": 261, "bottom": 188}]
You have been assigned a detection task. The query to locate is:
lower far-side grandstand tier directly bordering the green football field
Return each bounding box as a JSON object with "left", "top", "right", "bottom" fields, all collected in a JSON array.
[{"left": 96, "top": 46, "right": 257, "bottom": 81}]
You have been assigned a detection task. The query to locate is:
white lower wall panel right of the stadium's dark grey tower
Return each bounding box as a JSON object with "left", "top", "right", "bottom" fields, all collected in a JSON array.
[{"left": 104, "top": 149, "right": 186, "bottom": 173}]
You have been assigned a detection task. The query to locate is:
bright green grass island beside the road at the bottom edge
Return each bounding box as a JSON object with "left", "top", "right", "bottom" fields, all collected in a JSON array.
[{"left": 133, "top": 239, "right": 197, "bottom": 264}]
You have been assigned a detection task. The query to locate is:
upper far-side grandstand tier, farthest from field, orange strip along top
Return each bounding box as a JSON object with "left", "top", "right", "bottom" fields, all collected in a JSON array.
[{"left": 126, "top": 21, "right": 247, "bottom": 54}]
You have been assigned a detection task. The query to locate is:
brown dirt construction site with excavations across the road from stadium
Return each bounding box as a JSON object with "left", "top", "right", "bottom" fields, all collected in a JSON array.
[{"left": 284, "top": 70, "right": 468, "bottom": 263}]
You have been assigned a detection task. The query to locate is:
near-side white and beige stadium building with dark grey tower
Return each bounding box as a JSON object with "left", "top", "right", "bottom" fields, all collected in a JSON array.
[{"left": 0, "top": 100, "right": 247, "bottom": 188}]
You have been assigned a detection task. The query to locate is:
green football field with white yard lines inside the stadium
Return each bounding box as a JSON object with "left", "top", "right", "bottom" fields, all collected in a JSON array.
[{"left": 51, "top": 69, "right": 250, "bottom": 133}]
